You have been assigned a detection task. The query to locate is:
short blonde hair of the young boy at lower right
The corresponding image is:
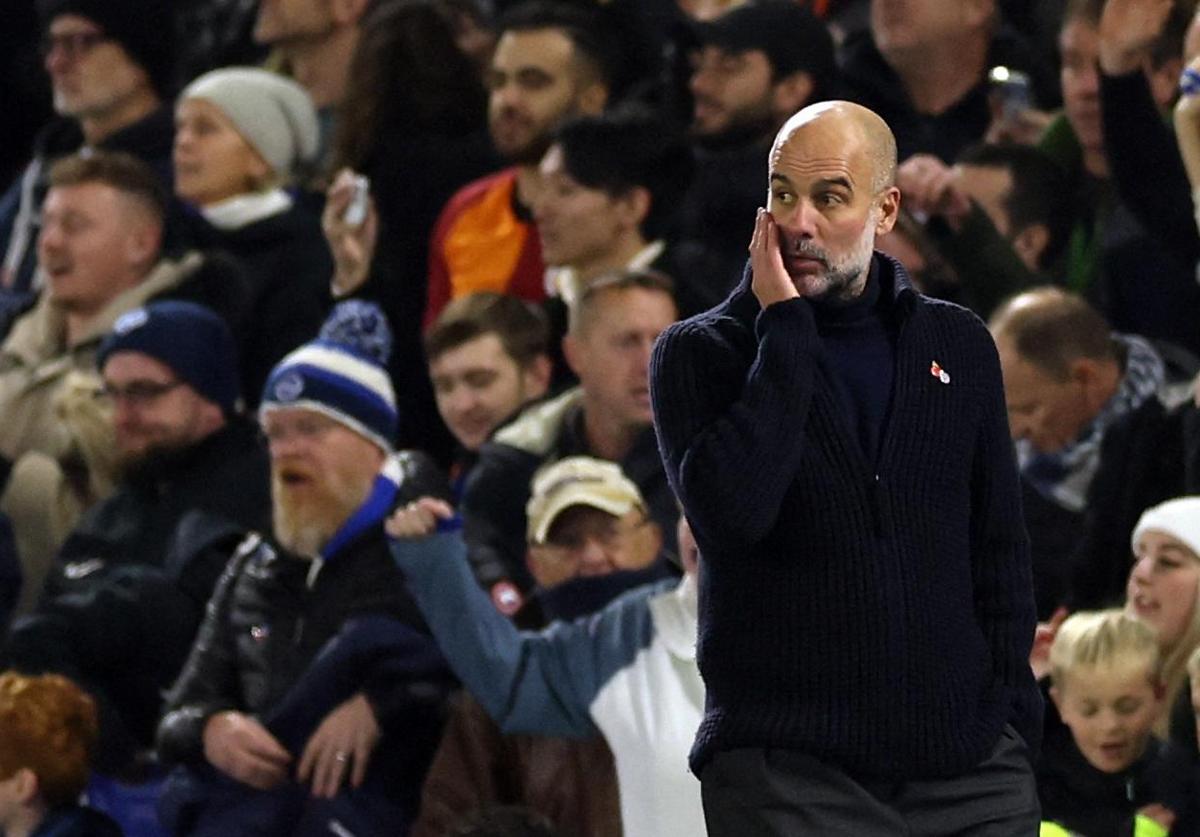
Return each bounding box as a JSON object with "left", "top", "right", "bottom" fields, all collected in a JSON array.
[{"left": 1050, "top": 601, "right": 1163, "bottom": 687}]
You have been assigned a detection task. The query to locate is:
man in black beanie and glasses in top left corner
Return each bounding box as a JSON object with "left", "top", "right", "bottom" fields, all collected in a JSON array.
[{"left": 0, "top": 0, "right": 174, "bottom": 311}]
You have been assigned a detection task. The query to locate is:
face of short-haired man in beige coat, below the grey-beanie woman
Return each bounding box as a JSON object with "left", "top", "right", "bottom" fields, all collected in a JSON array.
[{"left": 37, "top": 182, "right": 152, "bottom": 312}]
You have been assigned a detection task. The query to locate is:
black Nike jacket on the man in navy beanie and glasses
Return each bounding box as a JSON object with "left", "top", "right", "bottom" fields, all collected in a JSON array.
[{"left": 4, "top": 421, "right": 270, "bottom": 772}]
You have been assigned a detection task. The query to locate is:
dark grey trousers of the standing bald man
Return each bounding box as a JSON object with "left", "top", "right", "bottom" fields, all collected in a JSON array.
[{"left": 701, "top": 727, "right": 1042, "bottom": 837}]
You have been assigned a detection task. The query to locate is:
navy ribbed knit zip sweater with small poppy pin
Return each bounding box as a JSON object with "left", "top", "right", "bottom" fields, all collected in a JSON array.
[{"left": 650, "top": 254, "right": 1042, "bottom": 779}]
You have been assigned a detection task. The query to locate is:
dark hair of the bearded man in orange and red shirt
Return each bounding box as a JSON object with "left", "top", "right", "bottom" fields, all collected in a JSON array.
[{"left": 496, "top": 0, "right": 625, "bottom": 95}]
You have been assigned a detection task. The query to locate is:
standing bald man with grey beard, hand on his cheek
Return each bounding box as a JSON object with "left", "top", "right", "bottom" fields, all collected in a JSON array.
[{"left": 650, "top": 102, "right": 1042, "bottom": 837}]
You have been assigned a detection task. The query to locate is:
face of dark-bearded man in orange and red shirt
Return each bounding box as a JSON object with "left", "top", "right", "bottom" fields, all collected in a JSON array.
[{"left": 486, "top": 29, "right": 582, "bottom": 163}]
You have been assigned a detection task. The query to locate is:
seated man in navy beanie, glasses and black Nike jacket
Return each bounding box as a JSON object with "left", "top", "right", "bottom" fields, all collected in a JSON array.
[{"left": 5, "top": 302, "right": 270, "bottom": 773}]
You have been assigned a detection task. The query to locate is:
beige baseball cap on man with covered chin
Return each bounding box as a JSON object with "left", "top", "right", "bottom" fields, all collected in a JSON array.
[{"left": 526, "top": 457, "right": 646, "bottom": 543}]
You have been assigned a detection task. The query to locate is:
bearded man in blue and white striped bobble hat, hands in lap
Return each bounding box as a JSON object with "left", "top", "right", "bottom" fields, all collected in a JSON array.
[{"left": 158, "top": 302, "right": 452, "bottom": 835}]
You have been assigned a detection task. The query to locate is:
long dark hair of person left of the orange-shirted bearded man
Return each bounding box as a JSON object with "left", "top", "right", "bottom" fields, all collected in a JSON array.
[{"left": 334, "top": 0, "right": 487, "bottom": 170}]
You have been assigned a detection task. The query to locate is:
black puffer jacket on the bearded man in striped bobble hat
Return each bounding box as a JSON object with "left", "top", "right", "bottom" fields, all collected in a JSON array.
[{"left": 158, "top": 525, "right": 450, "bottom": 764}]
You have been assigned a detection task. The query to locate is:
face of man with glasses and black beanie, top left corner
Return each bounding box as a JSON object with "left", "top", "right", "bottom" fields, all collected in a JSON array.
[{"left": 44, "top": 14, "right": 150, "bottom": 119}]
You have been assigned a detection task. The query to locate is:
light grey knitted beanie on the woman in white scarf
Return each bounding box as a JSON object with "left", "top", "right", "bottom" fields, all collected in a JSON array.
[{"left": 179, "top": 67, "right": 320, "bottom": 176}]
